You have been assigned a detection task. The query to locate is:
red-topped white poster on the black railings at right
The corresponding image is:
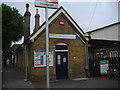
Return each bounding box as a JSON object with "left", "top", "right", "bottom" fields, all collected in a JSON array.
[{"left": 100, "top": 60, "right": 108, "bottom": 75}]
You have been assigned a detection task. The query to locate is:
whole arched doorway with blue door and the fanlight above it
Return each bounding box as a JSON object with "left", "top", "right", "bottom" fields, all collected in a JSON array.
[{"left": 56, "top": 43, "right": 68, "bottom": 79}]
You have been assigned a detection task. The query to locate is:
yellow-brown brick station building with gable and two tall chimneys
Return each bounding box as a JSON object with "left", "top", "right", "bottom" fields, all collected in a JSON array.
[{"left": 16, "top": 4, "right": 87, "bottom": 80}]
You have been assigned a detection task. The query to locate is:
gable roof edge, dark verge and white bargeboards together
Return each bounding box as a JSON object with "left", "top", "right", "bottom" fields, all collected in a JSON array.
[{"left": 28, "top": 6, "right": 84, "bottom": 40}]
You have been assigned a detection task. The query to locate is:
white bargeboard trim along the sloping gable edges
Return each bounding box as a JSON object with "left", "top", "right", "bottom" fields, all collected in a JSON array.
[{"left": 30, "top": 9, "right": 84, "bottom": 41}]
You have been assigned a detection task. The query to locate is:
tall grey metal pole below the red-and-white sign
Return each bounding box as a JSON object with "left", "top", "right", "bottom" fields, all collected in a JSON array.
[{"left": 45, "top": 7, "right": 50, "bottom": 88}]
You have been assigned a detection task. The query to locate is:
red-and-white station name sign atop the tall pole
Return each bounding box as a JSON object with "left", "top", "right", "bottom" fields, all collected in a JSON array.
[{"left": 35, "top": 0, "right": 58, "bottom": 8}]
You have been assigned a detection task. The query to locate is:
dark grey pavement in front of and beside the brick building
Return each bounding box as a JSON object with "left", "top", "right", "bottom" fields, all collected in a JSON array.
[{"left": 3, "top": 66, "right": 120, "bottom": 90}]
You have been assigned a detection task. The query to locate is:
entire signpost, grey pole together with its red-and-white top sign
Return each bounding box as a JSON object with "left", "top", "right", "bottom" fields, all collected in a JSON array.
[{"left": 35, "top": 0, "right": 58, "bottom": 88}]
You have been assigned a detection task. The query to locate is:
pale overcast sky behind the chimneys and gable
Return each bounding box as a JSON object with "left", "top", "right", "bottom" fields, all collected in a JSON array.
[{"left": 3, "top": 0, "right": 118, "bottom": 33}]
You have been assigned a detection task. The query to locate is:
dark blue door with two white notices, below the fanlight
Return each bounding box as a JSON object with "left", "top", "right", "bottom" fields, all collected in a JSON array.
[{"left": 56, "top": 52, "right": 68, "bottom": 79}]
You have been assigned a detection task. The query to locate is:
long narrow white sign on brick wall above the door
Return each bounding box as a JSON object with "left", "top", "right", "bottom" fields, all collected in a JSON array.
[{"left": 49, "top": 34, "right": 76, "bottom": 39}]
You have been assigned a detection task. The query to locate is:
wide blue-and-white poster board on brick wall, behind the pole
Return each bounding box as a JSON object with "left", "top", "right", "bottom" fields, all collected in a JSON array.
[{"left": 34, "top": 51, "right": 53, "bottom": 67}]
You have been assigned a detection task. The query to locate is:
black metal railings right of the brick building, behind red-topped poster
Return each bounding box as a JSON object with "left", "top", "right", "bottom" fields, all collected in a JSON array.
[{"left": 89, "top": 57, "right": 120, "bottom": 77}]
